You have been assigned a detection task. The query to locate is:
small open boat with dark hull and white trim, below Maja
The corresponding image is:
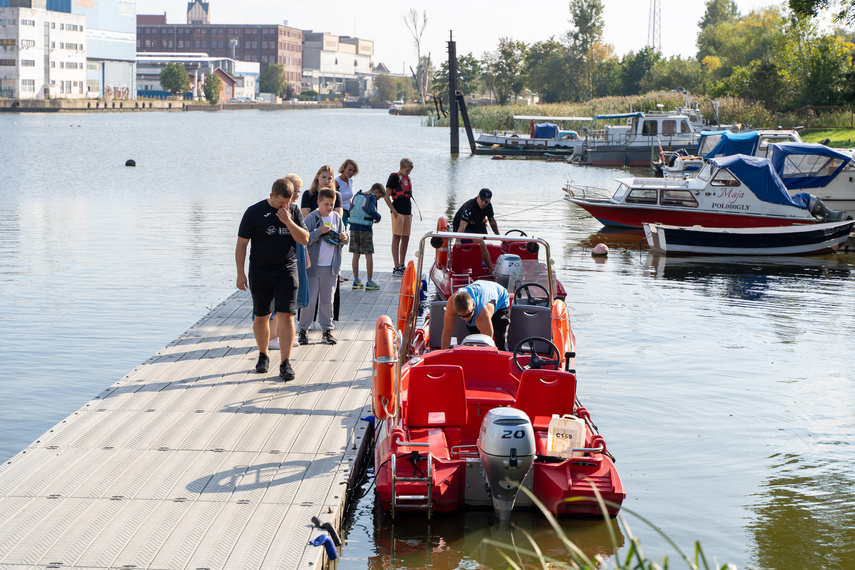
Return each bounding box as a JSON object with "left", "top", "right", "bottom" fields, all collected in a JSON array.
[{"left": 644, "top": 220, "right": 855, "bottom": 255}]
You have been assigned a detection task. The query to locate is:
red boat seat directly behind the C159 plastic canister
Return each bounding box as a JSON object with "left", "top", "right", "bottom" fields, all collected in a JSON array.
[{"left": 514, "top": 370, "right": 576, "bottom": 430}]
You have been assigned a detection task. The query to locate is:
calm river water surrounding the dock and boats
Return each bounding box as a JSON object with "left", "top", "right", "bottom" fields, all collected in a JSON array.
[{"left": 0, "top": 110, "right": 855, "bottom": 570}]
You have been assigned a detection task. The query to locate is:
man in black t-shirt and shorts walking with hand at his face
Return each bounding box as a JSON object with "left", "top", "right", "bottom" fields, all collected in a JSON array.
[{"left": 235, "top": 178, "right": 309, "bottom": 381}]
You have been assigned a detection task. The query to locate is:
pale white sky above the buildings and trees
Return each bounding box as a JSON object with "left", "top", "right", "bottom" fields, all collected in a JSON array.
[{"left": 136, "top": 0, "right": 786, "bottom": 73}]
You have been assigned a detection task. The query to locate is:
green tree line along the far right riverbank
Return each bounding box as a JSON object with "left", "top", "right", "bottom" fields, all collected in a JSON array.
[{"left": 428, "top": 0, "right": 855, "bottom": 112}]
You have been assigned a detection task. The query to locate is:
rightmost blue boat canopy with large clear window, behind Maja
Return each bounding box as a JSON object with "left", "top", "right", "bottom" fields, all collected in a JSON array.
[{"left": 769, "top": 143, "right": 852, "bottom": 190}]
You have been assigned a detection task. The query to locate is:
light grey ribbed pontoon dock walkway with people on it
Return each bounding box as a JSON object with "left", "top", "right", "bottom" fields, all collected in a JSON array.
[{"left": 0, "top": 274, "right": 400, "bottom": 570}]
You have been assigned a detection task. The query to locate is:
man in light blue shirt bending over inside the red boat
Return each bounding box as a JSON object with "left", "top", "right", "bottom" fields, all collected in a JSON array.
[{"left": 441, "top": 281, "right": 510, "bottom": 350}]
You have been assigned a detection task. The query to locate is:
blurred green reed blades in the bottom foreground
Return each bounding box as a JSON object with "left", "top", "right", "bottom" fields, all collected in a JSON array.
[{"left": 482, "top": 487, "right": 736, "bottom": 570}]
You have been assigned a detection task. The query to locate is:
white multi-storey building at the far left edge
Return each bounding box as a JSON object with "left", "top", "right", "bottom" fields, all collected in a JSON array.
[{"left": 0, "top": 0, "right": 86, "bottom": 99}]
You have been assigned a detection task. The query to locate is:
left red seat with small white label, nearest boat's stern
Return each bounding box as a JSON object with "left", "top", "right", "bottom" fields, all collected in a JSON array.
[{"left": 405, "top": 364, "right": 466, "bottom": 428}]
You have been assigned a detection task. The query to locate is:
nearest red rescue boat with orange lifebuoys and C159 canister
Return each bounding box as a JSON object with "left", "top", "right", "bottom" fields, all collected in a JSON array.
[{"left": 373, "top": 232, "right": 626, "bottom": 519}]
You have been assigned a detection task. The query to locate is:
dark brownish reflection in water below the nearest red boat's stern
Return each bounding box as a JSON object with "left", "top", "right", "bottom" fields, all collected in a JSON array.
[{"left": 369, "top": 504, "right": 624, "bottom": 569}]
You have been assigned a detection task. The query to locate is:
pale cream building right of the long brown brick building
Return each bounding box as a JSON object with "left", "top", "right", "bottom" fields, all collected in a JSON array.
[{"left": 302, "top": 31, "right": 375, "bottom": 97}]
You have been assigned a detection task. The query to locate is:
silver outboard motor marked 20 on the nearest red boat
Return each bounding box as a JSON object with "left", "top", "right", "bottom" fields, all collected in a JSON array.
[{"left": 478, "top": 408, "right": 535, "bottom": 521}]
